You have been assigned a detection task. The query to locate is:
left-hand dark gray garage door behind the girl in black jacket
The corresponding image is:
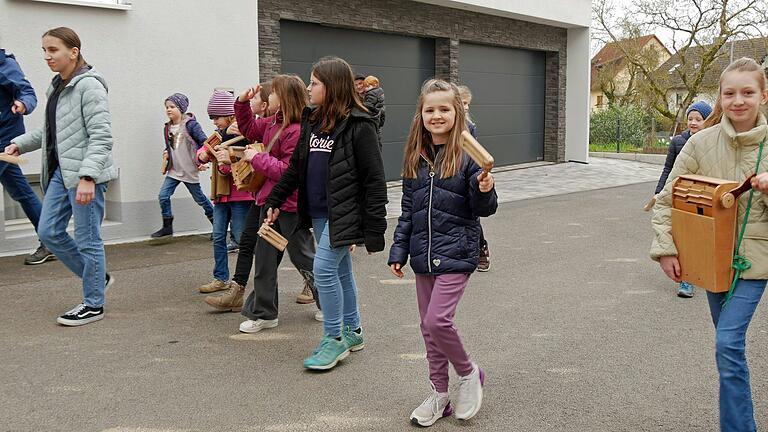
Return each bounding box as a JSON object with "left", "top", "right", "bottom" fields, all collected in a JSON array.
[{"left": 280, "top": 20, "right": 435, "bottom": 180}]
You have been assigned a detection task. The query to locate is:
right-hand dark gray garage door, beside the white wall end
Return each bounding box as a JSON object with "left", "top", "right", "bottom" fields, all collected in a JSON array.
[{"left": 459, "top": 43, "right": 545, "bottom": 165}]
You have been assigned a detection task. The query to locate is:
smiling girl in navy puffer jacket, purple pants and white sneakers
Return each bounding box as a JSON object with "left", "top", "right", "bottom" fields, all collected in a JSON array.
[{"left": 388, "top": 79, "right": 497, "bottom": 426}]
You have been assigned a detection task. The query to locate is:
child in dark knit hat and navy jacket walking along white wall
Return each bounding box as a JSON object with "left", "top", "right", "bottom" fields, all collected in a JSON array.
[{"left": 151, "top": 93, "right": 213, "bottom": 239}]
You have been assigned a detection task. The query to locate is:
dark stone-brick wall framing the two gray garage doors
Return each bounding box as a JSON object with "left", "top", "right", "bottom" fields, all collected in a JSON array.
[{"left": 258, "top": 0, "right": 567, "bottom": 162}]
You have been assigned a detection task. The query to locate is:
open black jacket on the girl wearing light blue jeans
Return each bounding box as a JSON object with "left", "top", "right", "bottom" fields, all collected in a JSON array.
[{"left": 265, "top": 107, "right": 387, "bottom": 252}]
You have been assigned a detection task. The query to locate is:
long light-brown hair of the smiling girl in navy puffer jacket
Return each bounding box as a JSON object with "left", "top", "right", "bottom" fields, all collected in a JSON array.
[{"left": 403, "top": 79, "right": 467, "bottom": 178}]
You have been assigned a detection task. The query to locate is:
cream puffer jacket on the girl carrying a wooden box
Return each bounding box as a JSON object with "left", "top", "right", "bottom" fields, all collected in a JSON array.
[{"left": 651, "top": 114, "right": 768, "bottom": 279}]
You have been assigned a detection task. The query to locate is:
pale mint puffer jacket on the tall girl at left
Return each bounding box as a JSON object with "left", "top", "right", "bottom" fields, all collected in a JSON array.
[{"left": 11, "top": 68, "right": 117, "bottom": 189}]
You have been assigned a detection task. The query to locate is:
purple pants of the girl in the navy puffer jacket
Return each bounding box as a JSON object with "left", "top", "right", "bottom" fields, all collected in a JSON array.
[{"left": 416, "top": 274, "right": 472, "bottom": 393}]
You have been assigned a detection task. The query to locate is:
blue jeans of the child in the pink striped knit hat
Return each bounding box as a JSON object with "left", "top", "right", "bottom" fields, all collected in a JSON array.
[{"left": 213, "top": 201, "right": 253, "bottom": 282}]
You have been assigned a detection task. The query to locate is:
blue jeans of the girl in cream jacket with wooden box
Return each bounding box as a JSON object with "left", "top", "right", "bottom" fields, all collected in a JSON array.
[{"left": 707, "top": 279, "right": 766, "bottom": 432}]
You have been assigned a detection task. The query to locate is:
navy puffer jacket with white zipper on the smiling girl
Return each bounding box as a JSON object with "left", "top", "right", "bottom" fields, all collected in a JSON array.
[{"left": 388, "top": 149, "right": 498, "bottom": 275}]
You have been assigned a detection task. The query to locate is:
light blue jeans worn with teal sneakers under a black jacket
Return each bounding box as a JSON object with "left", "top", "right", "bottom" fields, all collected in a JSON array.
[{"left": 312, "top": 218, "right": 360, "bottom": 337}]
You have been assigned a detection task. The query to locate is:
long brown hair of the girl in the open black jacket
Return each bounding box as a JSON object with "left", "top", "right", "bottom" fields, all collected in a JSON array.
[{"left": 310, "top": 57, "right": 368, "bottom": 132}]
